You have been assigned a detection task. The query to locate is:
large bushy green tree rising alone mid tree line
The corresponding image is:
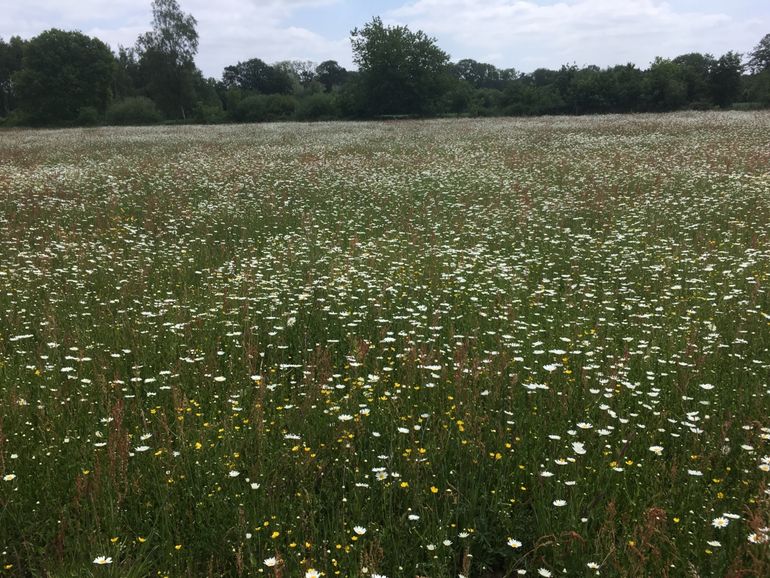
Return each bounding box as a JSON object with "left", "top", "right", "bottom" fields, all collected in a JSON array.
[{"left": 350, "top": 18, "right": 449, "bottom": 116}]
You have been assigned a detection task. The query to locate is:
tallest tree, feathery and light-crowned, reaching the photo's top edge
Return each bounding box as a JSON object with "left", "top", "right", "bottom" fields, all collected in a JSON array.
[{"left": 136, "top": 0, "right": 198, "bottom": 118}]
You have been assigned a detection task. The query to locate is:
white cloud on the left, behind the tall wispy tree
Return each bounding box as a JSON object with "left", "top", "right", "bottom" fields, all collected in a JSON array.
[{"left": 0, "top": 0, "right": 351, "bottom": 78}]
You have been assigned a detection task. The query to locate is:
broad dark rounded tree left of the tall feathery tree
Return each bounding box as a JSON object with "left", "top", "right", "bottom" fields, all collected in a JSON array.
[{"left": 13, "top": 28, "right": 115, "bottom": 124}]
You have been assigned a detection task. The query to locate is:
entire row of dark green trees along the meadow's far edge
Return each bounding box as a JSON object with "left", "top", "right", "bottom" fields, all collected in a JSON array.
[{"left": 0, "top": 0, "right": 770, "bottom": 126}]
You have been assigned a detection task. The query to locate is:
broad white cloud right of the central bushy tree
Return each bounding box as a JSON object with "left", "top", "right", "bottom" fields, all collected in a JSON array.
[{"left": 386, "top": 0, "right": 766, "bottom": 71}]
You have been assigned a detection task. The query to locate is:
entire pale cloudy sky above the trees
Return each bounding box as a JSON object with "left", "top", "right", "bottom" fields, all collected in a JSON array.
[{"left": 0, "top": 0, "right": 770, "bottom": 78}]
